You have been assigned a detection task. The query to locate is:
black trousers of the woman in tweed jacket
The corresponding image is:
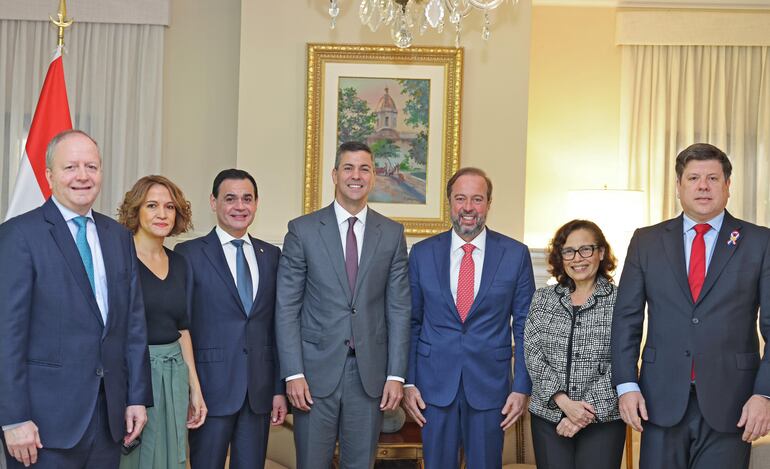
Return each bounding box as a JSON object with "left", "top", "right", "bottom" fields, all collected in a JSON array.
[{"left": 532, "top": 415, "right": 628, "bottom": 469}]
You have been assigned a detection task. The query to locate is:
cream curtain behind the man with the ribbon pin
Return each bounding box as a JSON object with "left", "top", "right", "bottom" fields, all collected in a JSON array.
[{"left": 620, "top": 45, "right": 770, "bottom": 225}]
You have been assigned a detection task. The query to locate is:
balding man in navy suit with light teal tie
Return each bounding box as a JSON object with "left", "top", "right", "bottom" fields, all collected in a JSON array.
[{"left": 0, "top": 130, "right": 152, "bottom": 469}]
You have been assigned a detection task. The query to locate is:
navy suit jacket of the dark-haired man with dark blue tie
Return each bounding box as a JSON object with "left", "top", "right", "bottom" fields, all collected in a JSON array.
[{"left": 174, "top": 229, "right": 284, "bottom": 416}]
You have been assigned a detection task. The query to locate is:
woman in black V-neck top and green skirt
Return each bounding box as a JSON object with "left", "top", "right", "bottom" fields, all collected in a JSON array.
[{"left": 118, "top": 176, "right": 207, "bottom": 469}]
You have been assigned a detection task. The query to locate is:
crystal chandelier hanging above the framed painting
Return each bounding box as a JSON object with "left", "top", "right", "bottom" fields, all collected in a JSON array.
[{"left": 329, "top": 0, "right": 519, "bottom": 49}]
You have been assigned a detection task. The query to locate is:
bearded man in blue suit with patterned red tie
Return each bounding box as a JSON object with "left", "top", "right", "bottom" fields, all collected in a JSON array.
[{"left": 404, "top": 168, "right": 535, "bottom": 469}]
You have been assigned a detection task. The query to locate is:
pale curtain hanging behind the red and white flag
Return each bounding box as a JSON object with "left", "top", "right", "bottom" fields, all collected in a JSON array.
[{"left": 0, "top": 20, "right": 165, "bottom": 220}]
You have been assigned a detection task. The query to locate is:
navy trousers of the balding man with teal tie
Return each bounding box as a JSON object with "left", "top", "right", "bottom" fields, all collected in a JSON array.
[{"left": 6, "top": 388, "right": 120, "bottom": 469}]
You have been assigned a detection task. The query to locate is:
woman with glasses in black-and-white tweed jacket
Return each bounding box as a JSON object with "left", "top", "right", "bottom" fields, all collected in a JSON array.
[{"left": 524, "top": 220, "right": 625, "bottom": 469}]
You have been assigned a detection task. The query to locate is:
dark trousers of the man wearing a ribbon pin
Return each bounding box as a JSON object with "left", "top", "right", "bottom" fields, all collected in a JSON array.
[{"left": 639, "top": 392, "right": 751, "bottom": 469}]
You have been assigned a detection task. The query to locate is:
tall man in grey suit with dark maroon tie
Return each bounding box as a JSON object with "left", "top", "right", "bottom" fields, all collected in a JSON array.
[{"left": 276, "top": 142, "right": 410, "bottom": 469}]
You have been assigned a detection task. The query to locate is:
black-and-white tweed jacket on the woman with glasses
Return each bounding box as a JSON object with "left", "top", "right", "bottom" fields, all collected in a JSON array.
[{"left": 524, "top": 277, "right": 620, "bottom": 423}]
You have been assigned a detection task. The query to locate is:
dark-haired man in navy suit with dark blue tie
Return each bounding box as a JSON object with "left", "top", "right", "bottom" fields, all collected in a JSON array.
[{"left": 176, "top": 169, "right": 286, "bottom": 469}]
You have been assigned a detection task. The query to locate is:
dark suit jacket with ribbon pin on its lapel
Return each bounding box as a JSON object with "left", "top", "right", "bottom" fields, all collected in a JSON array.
[{"left": 612, "top": 211, "right": 770, "bottom": 432}]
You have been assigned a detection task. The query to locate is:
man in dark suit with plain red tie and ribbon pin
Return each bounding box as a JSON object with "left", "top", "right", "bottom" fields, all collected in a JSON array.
[{"left": 612, "top": 143, "right": 770, "bottom": 469}]
